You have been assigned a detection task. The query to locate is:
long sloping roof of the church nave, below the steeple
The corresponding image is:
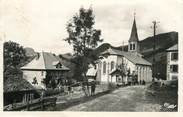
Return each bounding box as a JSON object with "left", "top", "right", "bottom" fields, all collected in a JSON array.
[{"left": 102, "top": 48, "right": 152, "bottom": 66}]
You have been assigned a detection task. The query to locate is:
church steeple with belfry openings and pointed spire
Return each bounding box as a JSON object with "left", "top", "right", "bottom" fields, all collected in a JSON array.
[{"left": 128, "top": 13, "right": 139, "bottom": 52}]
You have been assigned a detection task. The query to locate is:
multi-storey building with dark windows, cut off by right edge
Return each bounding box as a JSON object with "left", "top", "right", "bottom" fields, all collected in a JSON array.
[{"left": 167, "top": 44, "right": 178, "bottom": 80}]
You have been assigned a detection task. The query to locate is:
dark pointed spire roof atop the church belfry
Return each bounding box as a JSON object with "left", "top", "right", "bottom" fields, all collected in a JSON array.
[{"left": 129, "top": 18, "right": 139, "bottom": 42}]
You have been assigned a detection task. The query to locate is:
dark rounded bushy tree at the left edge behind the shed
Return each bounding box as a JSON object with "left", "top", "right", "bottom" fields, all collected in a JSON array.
[{"left": 4, "top": 41, "right": 27, "bottom": 80}]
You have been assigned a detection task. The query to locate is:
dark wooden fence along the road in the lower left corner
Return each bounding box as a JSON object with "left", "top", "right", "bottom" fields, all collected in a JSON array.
[{"left": 4, "top": 97, "right": 57, "bottom": 111}]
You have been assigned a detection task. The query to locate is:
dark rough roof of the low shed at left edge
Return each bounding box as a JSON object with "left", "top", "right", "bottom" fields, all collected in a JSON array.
[{"left": 3, "top": 78, "right": 35, "bottom": 93}]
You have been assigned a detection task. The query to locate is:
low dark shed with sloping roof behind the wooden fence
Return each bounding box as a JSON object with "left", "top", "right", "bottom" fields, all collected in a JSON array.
[{"left": 3, "top": 78, "right": 39, "bottom": 106}]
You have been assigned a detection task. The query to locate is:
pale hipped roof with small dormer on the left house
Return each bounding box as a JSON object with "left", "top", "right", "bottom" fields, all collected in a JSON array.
[{"left": 21, "top": 52, "right": 69, "bottom": 70}]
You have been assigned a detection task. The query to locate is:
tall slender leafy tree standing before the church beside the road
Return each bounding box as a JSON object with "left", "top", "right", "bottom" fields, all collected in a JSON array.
[{"left": 65, "top": 8, "right": 103, "bottom": 95}]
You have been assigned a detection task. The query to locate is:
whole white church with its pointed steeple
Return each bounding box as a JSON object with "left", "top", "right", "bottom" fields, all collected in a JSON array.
[{"left": 88, "top": 14, "right": 152, "bottom": 84}]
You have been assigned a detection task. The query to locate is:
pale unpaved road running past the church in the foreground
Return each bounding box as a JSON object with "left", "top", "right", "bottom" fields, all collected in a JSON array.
[{"left": 56, "top": 86, "right": 163, "bottom": 112}]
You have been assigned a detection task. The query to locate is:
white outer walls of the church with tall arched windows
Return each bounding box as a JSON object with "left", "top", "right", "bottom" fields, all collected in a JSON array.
[{"left": 97, "top": 55, "right": 152, "bottom": 82}]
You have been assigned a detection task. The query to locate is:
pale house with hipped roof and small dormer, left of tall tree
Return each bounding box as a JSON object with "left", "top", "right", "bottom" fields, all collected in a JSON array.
[{"left": 21, "top": 52, "right": 69, "bottom": 89}]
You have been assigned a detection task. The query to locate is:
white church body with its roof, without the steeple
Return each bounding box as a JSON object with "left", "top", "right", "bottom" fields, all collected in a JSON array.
[{"left": 96, "top": 48, "right": 152, "bottom": 83}]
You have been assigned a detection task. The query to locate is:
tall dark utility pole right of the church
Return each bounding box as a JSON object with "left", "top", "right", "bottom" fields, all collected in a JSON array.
[{"left": 152, "top": 20, "right": 159, "bottom": 81}]
